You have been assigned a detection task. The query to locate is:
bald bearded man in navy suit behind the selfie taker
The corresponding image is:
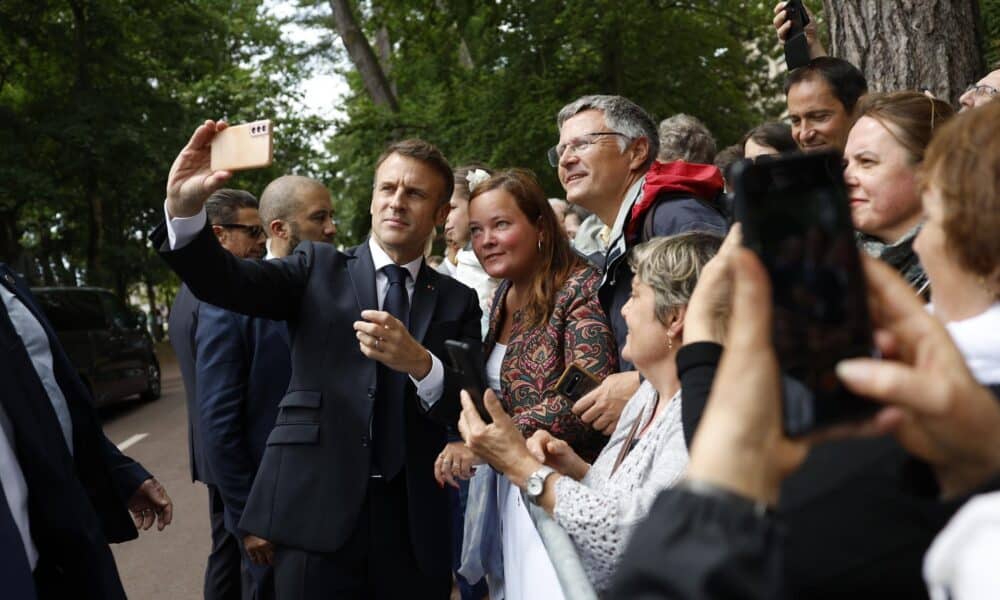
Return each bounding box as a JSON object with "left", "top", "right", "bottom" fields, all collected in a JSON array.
[{"left": 201, "top": 180, "right": 336, "bottom": 600}]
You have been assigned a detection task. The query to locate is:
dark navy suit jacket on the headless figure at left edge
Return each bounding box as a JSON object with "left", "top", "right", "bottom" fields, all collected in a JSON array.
[{"left": 0, "top": 263, "right": 151, "bottom": 599}]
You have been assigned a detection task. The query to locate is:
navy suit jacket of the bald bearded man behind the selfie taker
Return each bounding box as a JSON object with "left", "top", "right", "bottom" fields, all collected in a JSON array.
[{"left": 195, "top": 303, "right": 292, "bottom": 537}]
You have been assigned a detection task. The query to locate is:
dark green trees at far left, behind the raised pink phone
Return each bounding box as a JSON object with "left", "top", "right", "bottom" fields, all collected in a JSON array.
[{"left": 0, "top": 0, "right": 323, "bottom": 295}]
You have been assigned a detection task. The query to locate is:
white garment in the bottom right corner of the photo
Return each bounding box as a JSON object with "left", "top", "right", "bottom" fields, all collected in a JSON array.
[{"left": 924, "top": 492, "right": 1000, "bottom": 600}]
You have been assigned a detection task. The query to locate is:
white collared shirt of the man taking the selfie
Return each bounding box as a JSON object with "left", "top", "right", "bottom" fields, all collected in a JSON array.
[{"left": 163, "top": 200, "right": 444, "bottom": 410}]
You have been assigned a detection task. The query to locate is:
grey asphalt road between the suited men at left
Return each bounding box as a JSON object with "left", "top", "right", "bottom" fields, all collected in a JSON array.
[{"left": 102, "top": 344, "right": 211, "bottom": 600}]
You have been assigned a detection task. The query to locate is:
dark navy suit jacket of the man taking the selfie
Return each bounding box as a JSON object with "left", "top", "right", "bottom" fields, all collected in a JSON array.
[{"left": 152, "top": 224, "right": 481, "bottom": 574}]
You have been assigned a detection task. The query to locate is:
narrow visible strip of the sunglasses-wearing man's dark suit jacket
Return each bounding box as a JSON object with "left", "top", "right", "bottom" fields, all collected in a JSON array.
[{"left": 167, "top": 283, "right": 214, "bottom": 485}]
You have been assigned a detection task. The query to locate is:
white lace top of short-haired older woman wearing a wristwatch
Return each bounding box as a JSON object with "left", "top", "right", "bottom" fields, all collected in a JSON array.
[{"left": 554, "top": 381, "right": 688, "bottom": 592}]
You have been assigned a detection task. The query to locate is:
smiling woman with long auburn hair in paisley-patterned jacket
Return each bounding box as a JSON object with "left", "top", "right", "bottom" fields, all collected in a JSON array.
[{"left": 456, "top": 170, "right": 617, "bottom": 600}]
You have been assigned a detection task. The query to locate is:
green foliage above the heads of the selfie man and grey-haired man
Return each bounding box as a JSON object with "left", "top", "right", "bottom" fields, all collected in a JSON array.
[{"left": 312, "top": 0, "right": 780, "bottom": 243}]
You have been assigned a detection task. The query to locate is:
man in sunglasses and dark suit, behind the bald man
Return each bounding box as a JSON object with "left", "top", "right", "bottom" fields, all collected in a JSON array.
[{"left": 169, "top": 189, "right": 273, "bottom": 600}]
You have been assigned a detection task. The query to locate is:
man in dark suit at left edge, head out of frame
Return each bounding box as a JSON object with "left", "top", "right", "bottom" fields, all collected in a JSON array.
[{"left": 0, "top": 263, "right": 173, "bottom": 600}]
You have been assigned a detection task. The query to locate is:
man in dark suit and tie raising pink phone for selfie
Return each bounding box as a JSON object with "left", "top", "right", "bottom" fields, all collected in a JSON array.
[{"left": 153, "top": 121, "right": 480, "bottom": 599}]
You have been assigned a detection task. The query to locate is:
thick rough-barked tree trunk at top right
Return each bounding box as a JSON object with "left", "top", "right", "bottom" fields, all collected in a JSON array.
[{"left": 823, "top": 0, "right": 983, "bottom": 103}]
